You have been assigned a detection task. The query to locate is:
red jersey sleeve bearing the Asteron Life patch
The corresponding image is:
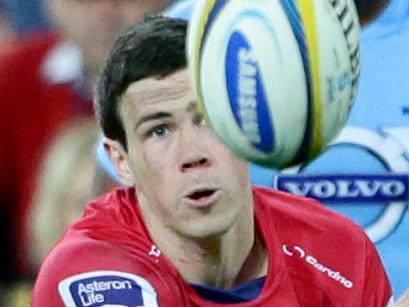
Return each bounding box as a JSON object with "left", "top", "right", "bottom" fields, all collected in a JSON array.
[{"left": 31, "top": 242, "right": 183, "bottom": 307}]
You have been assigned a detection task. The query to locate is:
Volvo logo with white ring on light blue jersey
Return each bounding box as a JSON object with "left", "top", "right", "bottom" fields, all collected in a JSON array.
[{"left": 273, "top": 126, "right": 409, "bottom": 242}]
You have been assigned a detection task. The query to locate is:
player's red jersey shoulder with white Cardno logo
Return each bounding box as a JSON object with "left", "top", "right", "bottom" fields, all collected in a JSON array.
[{"left": 254, "top": 188, "right": 391, "bottom": 306}]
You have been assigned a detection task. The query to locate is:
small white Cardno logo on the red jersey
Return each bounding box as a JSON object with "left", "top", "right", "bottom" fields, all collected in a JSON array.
[{"left": 282, "top": 244, "right": 354, "bottom": 289}]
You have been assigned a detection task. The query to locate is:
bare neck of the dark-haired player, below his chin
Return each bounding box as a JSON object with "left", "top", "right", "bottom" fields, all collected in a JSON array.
[{"left": 139, "top": 195, "right": 268, "bottom": 289}]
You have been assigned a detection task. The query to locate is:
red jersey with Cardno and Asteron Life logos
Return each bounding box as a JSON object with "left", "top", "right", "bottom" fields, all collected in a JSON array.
[{"left": 33, "top": 187, "right": 392, "bottom": 307}]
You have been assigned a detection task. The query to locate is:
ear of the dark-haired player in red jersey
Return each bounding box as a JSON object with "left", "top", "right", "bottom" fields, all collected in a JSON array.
[{"left": 103, "top": 138, "right": 135, "bottom": 187}]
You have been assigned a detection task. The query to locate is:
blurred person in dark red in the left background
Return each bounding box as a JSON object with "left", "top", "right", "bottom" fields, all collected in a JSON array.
[{"left": 0, "top": 0, "right": 171, "bottom": 286}]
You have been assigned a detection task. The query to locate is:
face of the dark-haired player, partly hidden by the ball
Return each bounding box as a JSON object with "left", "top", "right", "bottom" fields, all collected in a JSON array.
[{"left": 113, "top": 70, "right": 251, "bottom": 238}]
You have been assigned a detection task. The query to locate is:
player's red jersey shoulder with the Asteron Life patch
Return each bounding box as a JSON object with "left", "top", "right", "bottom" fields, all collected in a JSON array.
[{"left": 33, "top": 200, "right": 180, "bottom": 307}]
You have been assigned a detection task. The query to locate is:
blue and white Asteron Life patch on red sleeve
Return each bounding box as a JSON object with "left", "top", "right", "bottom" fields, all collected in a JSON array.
[{"left": 58, "top": 271, "right": 158, "bottom": 307}]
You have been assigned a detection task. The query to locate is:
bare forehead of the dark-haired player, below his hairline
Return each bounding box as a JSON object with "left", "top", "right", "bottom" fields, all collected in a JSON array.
[{"left": 120, "top": 69, "right": 194, "bottom": 113}]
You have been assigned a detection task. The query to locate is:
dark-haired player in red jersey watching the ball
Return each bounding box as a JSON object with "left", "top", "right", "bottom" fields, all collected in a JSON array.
[{"left": 33, "top": 17, "right": 391, "bottom": 307}]
